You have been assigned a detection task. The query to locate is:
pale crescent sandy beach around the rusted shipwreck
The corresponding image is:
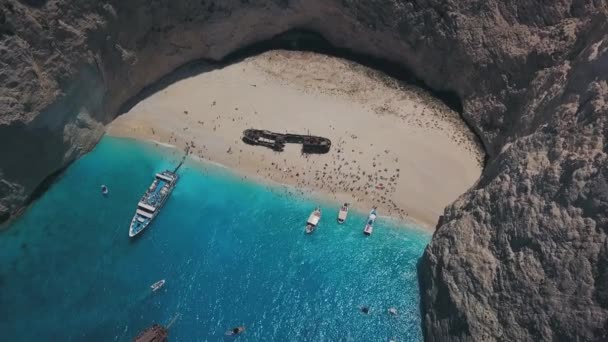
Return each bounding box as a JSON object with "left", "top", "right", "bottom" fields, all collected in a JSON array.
[{"left": 107, "top": 51, "right": 483, "bottom": 229}]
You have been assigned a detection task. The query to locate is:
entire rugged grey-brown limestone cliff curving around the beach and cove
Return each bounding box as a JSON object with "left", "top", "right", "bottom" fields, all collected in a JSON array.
[{"left": 0, "top": 0, "right": 608, "bottom": 341}]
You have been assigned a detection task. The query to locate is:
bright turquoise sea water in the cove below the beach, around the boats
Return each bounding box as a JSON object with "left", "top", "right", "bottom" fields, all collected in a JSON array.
[{"left": 0, "top": 137, "right": 431, "bottom": 341}]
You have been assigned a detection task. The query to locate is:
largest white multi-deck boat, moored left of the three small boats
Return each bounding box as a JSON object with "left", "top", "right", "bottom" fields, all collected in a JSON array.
[{"left": 129, "top": 169, "right": 178, "bottom": 237}]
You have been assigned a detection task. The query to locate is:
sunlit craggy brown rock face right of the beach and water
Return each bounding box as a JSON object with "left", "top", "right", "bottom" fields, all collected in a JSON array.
[{"left": 419, "top": 8, "right": 608, "bottom": 341}]
